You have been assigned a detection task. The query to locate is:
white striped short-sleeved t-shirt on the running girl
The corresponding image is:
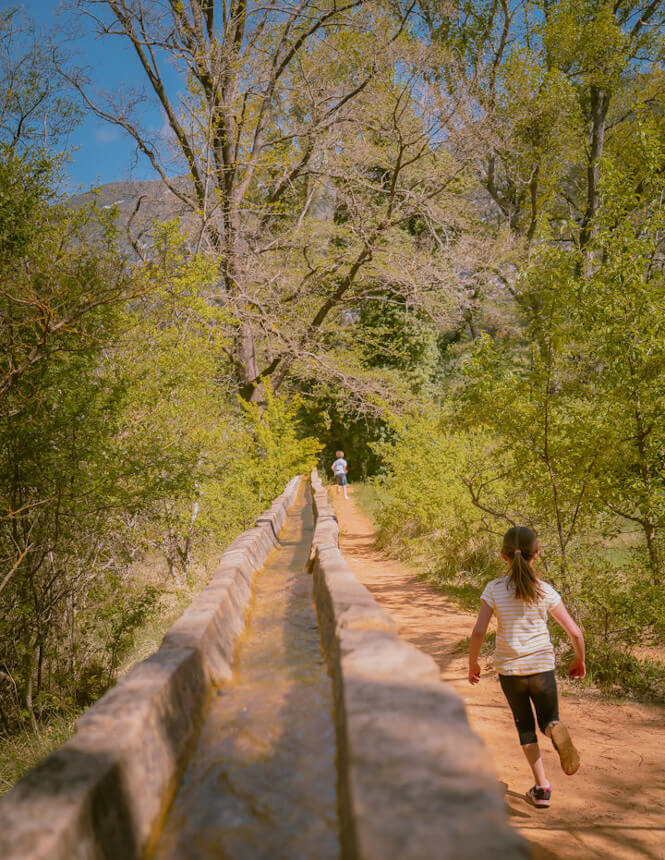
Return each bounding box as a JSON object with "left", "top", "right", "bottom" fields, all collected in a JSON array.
[{"left": 480, "top": 576, "right": 561, "bottom": 675}]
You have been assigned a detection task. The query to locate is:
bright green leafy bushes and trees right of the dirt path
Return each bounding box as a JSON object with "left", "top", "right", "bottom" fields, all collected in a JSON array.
[{"left": 368, "top": 124, "right": 665, "bottom": 700}]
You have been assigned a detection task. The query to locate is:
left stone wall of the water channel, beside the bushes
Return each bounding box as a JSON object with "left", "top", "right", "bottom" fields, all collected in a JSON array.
[{"left": 0, "top": 476, "right": 301, "bottom": 860}]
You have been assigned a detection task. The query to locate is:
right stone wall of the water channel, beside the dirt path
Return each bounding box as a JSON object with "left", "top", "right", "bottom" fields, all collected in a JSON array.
[{"left": 311, "top": 470, "right": 529, "bottom": 860}]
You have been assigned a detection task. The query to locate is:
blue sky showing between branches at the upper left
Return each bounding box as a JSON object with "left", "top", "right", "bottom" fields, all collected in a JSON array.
[{"left": 26, "top": 0, "right": 175, "bottom": 190}]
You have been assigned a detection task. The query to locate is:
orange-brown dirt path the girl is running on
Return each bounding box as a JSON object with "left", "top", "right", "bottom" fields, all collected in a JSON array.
[{"left": 332, "top": 488, "right": 665, "bottom": 860}]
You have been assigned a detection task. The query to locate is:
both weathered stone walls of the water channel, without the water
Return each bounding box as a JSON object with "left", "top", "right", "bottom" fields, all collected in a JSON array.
[{"left": 0, "top": 471, "right": 528, "bottom": 860}]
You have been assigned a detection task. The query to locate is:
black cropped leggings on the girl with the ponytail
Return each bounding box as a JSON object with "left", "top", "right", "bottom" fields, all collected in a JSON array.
[{"left": 499, "top": 670, "right": 559, "bottom": 746}]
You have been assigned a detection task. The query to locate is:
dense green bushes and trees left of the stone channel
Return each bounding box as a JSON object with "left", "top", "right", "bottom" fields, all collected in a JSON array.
[{"left": 0, "top": 175, "right": 318, "bottom": 734}]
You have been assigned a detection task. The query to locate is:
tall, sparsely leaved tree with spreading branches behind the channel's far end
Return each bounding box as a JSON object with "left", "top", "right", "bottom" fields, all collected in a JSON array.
[{"left": 69, "top": 0, "right": 488, "bottom": 400}]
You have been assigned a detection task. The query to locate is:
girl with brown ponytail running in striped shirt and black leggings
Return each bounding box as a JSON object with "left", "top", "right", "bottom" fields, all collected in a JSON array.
[{"left": 469, "top": 526, "right": 586, "bottom": 807}]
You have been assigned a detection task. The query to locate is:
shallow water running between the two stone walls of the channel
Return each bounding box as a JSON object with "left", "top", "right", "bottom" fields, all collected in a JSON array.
[{"left": 152, "top": 489, "right": 340, "bottom": 860}]
